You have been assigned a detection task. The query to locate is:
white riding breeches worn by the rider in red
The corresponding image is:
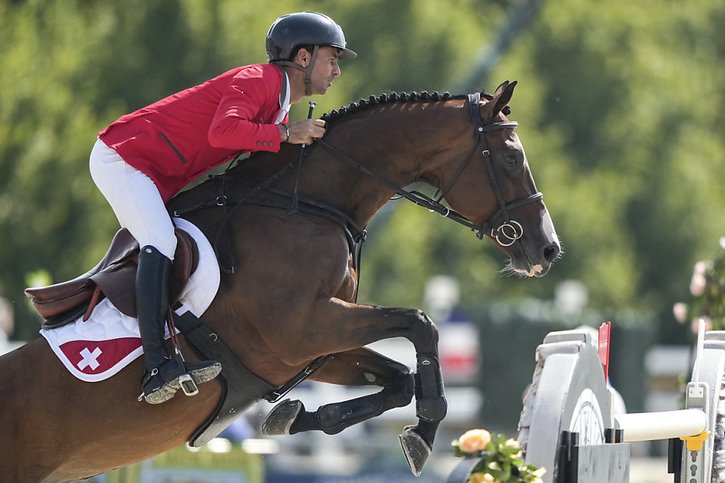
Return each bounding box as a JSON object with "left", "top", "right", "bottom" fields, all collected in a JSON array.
[{"left": 90, "top": 139, "right": 176, "bottom": 260}]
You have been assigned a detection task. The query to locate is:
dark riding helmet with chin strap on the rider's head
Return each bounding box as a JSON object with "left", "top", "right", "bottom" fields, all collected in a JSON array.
[{"left": 266, "top": 12, "right": 357, "bottom": 96}]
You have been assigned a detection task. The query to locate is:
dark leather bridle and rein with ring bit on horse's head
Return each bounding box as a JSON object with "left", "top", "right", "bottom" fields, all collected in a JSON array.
[{"left": 316, "top": 92, "right": 544, "bottom": 247}]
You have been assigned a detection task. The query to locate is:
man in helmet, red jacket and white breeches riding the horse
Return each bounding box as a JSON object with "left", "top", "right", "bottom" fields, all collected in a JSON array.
[{"left": 90, "top": 12, "right": 357, "bottom": 404}]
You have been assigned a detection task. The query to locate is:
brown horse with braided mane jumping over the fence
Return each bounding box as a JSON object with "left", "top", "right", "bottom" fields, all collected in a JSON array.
[{"left": 0, "top": 82, "right": 560, "bottom": 482}]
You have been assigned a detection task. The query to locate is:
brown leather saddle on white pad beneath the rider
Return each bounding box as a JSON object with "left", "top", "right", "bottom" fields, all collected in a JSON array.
[{"left": 25, "top": 228, "right": 199, "bottom": 329}]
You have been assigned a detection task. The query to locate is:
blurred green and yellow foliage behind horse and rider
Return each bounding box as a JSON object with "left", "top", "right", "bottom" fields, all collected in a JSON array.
[{"left": 0, "top": 0, "right": 725, "bottom": 356}]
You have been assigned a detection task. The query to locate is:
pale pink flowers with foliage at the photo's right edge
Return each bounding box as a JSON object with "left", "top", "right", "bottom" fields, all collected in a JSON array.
[{"left": 673, "top": 237, "right": 725, "bottom": 332}]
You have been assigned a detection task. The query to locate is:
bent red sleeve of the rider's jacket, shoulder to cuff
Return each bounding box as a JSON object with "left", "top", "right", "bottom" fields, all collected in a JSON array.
[{"left": 208, "top": 69, "right": 280, "bottom": 152}]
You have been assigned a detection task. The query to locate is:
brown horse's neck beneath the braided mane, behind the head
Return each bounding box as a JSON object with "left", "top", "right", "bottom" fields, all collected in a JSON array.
[{"left": 310, "top": 101, "right": 470, "bottom": 226}]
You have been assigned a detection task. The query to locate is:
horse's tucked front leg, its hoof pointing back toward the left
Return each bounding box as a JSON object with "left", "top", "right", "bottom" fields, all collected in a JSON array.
[{"left": 262, "top": 348, "right": 414, "bottom": 436}]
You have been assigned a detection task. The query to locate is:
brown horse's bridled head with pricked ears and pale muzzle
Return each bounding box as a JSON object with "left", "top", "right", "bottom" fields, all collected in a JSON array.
[{"left": 436, "top": 81, "right": 561, "bottom": 277}]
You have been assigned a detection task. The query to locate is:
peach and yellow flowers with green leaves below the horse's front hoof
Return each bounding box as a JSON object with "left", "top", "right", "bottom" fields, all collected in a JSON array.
[{"left": 451, "top": 429, "right": 546, "bottom": 483}]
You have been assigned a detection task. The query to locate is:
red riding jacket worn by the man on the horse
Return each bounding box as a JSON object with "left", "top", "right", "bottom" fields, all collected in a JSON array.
[{"left": 99, "top": 64, "right": 287, "bottom": 202}]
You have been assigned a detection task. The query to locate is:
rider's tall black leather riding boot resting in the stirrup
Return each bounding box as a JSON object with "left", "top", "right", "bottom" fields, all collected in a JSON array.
[{"left": 136, "top": 245, "right": 221, "bottom": 404}]
